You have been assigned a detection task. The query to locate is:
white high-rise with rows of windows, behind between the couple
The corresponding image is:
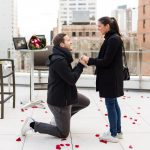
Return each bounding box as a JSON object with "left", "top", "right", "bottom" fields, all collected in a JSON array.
[{"left": 58, "top": 0, "right": 96, "bottom": 26}]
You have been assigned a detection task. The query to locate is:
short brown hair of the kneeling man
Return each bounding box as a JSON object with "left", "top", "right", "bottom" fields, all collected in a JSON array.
[{"left": 53, "top": 33, "right": 67, "bottom": 46}]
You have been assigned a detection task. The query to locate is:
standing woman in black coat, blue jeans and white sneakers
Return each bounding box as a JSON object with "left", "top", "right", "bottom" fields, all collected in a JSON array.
[{"left": 81, "top": 17, "right": 124, "bottom": 143}]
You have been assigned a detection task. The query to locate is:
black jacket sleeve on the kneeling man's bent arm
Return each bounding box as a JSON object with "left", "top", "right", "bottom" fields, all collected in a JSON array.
[{"left": 54, "top": 59, "right": 83, "bottom": 85}]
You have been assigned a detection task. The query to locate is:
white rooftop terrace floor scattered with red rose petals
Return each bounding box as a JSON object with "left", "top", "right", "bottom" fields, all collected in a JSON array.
[{"left": 0, "top": 86, "right": 150, "bottom": 150}]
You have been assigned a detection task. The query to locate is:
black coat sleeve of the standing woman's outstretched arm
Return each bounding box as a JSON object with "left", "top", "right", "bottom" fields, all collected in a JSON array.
[{"left": 88, "top": 38, "right": 120, "bottom": 67}]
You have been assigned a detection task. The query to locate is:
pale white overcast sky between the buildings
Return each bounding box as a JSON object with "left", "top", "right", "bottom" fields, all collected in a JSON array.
[{"left": 18, "top": 0, "right": 138, "bottom": 41}]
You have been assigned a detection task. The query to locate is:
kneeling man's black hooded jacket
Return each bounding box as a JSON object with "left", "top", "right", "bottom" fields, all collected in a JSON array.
[{"left": 47, "top": 46, "right": 84, "bottom": 107}]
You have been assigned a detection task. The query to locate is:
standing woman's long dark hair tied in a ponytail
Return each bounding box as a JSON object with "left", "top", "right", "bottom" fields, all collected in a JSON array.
[{"left": 98, "top": 17, "right": 121, "bottom": 36}]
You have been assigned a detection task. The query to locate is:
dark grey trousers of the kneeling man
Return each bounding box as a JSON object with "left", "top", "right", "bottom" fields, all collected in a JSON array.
[{"left": 34, "top": 93, "right": 90, "bottom": 138}]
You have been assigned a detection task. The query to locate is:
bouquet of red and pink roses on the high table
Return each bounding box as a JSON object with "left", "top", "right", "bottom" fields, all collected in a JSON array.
[{"left": 28, "top": 35, "right": 46, "bottom": 50}]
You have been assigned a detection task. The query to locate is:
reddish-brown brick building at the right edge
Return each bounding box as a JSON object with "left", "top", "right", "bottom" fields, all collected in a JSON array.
[{"left": 137, "top": 0, "right": 150, "bottom": 75}]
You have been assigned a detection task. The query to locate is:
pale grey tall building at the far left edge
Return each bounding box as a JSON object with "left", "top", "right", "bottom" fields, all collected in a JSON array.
[{"left": 0, "top": 0, "right": 18, "bottom": 58}]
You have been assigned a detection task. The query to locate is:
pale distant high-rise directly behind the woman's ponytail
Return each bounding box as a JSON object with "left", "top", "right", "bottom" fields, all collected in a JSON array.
[{"left": 112, "top": 5, "right": 138, "bottom": 35}]
